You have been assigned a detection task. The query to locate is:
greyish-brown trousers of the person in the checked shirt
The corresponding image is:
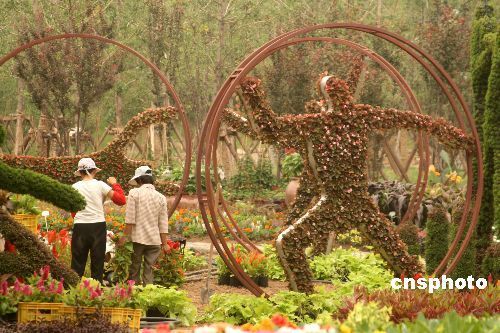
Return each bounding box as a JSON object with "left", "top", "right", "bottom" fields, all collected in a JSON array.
[{"left": 129, "top": 242, "right": 161, "bottom": 285}]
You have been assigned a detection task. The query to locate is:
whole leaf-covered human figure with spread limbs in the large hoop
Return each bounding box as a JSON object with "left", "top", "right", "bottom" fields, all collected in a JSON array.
[{"left": 225, "top": 75, "right": 473, "bottom": 293}]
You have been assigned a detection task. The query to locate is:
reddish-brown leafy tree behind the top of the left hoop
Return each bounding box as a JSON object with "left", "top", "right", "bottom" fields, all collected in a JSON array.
[{"left": 16, "top": 0, "right": 122, "bottom": 155}]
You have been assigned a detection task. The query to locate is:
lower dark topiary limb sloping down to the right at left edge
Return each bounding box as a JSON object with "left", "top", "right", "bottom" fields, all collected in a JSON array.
[{"left": 0, "top": 211, "right": 80, "bottom": 285}]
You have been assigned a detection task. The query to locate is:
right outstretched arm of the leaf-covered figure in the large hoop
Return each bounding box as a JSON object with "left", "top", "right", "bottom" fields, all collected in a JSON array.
[{"left": 356, "top": 106, "right": 474, "bottom": 151}]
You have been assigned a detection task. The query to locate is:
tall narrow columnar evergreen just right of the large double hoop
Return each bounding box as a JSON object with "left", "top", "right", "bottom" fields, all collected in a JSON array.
[{"left": 471, "top": 4, "right": 498, "bottom": 267}]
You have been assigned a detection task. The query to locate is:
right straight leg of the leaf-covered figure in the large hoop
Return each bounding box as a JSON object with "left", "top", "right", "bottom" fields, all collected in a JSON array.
[{"left": 356, "top": 199, "right": 423, "bottom": 276}]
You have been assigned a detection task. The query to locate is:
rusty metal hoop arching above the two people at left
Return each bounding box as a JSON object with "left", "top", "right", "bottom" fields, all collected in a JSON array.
[{"left": 0, "top": 33, "right": 192, "bottom": 216}]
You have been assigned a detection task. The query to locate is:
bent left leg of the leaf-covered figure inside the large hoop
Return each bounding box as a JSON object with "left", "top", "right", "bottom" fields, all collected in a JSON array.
[{"left": 276, "top": 195, "right": 331, "bottom": 293}]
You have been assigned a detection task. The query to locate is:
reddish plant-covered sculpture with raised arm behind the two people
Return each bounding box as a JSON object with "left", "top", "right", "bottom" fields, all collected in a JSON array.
[{"left": 0, "top": 107, "right": 179, "bottom": 195}]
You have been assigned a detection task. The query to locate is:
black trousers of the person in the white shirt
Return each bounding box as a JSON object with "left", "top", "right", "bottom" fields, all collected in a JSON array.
[{"left": 71, "top": 222, "right": 106, "bottom": 283}]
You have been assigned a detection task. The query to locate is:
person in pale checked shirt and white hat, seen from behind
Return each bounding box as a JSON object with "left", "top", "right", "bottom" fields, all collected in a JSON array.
[{"left": 120, "top": 166, "right": 170, "bottom": 285}]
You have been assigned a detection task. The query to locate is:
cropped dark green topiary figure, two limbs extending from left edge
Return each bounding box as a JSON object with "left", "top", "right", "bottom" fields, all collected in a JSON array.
[{"left": 0, "top": 127, "right": 85, "bottom": 284}]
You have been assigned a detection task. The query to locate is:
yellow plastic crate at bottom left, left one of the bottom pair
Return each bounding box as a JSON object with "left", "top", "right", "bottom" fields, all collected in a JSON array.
[{"left": 17, "top": 302, "right": 66, "bottom": 323}]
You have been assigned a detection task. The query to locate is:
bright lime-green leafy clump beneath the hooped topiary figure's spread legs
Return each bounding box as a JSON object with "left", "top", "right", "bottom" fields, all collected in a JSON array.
[{"left": 310, "top": 248, "right": 393, "bottom": 293}]
